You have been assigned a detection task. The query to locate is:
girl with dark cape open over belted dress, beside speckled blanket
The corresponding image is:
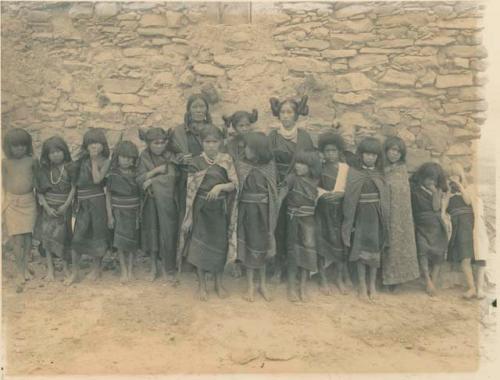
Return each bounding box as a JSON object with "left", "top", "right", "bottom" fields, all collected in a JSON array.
[{"left": 342, "top": 137, "right": 389, "bottom": 300}]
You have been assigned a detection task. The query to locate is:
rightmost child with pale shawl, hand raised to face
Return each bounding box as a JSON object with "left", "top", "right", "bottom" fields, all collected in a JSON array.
[{"left": 444, "top": 163, "right": 488, "bottom": 299}]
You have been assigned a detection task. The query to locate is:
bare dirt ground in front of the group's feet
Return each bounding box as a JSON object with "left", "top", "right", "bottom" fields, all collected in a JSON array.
[{"left": 3, "top": 251, "right": 495, "bottom": 375}]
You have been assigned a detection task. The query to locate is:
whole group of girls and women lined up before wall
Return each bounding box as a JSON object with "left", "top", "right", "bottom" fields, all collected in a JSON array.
[{"left": 2, "top": 95, "right": 487, "bottom": 302}]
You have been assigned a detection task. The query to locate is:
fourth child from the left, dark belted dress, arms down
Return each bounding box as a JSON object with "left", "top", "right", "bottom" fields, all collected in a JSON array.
[{"left": 106, "top": 141, "right": 140, "bottom": 283}]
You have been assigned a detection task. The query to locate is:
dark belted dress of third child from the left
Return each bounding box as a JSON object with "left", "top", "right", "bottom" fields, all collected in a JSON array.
[{"left": 72, "top": 158, "right": 110, "bottom": 255}]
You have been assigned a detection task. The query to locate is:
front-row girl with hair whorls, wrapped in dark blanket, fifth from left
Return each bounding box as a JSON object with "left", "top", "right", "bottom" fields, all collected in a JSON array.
[{"left": 137, "top": 127, "right": 179, "bottom": 284}]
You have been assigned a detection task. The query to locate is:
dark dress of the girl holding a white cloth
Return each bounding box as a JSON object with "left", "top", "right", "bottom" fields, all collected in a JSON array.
[{"left": 316, "top": 165, "right": 347, "bottom": 265}]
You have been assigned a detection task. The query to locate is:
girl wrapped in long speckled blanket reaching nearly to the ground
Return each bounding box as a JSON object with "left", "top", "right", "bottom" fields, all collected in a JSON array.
[{"left": 382, "top": 136, "right": 419, "bottom": 286}]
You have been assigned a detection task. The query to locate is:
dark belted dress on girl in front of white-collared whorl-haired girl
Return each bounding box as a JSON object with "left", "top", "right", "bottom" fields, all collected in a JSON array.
[{"left": 286, "top": 175, "right": 318, "bottom": 272}]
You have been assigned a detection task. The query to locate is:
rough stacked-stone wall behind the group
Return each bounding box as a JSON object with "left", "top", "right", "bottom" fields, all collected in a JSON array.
[{"left": 1, "top": 1, "right": 487, "bottom": 172}]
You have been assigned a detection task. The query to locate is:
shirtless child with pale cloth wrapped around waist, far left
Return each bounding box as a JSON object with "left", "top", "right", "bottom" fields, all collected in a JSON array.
[{"left": 2, "top": 128, "right": 37, "bottom": 292}]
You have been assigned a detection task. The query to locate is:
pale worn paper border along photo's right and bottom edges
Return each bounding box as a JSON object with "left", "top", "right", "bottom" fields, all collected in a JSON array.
[{"left": 0, "top": 0, "right": 500, "bottom": 380}]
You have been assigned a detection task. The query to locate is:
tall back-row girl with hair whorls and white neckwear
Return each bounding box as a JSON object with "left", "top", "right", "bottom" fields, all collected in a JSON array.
[{"left": 269, "top": 96, "right": 314, "bottom": 279}]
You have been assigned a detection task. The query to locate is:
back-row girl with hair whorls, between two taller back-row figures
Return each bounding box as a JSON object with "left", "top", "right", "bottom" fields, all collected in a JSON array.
[{"left": 222, "top": 109, "right": 258, "bottom": 161}]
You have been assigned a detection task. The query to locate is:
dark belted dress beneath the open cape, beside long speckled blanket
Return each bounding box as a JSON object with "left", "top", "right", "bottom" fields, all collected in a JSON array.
[{"left": 349, "top": 175, "right": 384, "bottom": 268}]
